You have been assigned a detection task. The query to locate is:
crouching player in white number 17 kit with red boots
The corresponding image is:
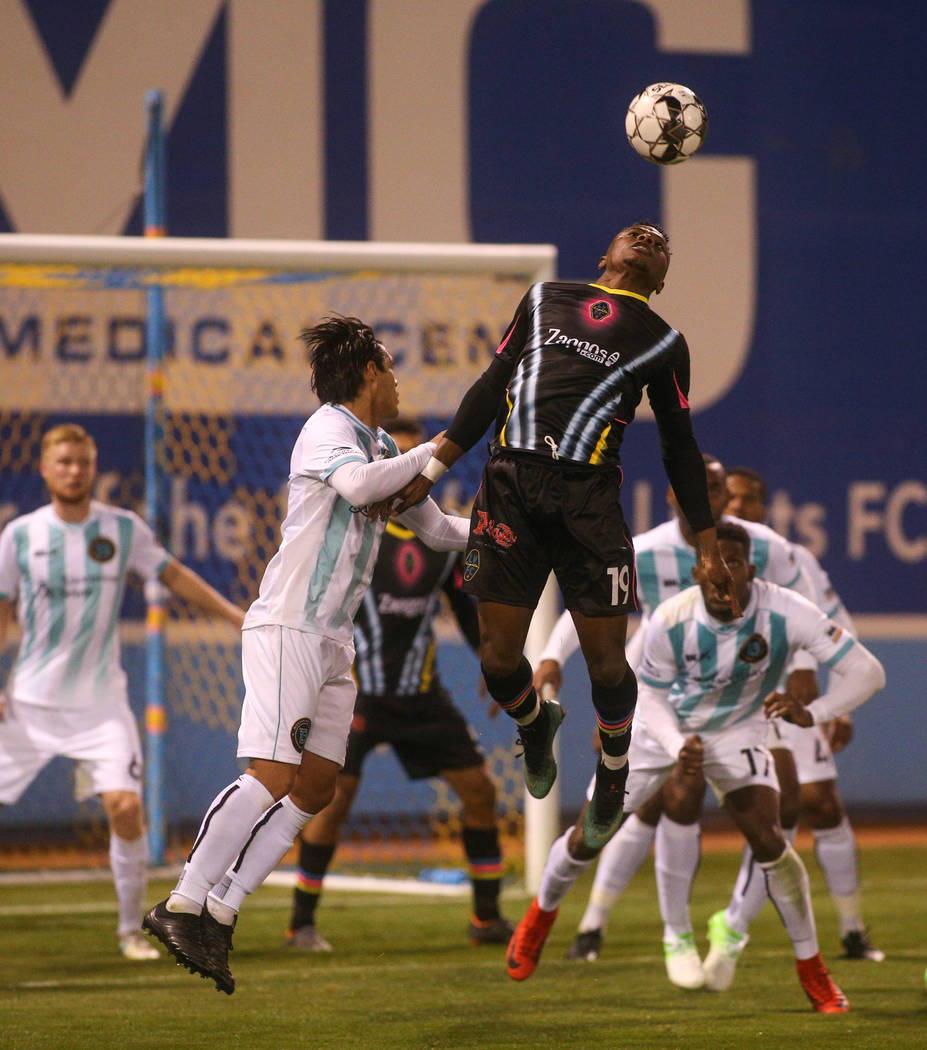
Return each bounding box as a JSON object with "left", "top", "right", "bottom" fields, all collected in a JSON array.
[{"left": 508, "top": 522, "right": 885, "bottom": 1013}]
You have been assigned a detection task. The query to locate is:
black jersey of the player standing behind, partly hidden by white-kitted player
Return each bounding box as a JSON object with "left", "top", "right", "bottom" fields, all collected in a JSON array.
[{"left": 354, "top": 522, "right": 480, "bottom": 696}]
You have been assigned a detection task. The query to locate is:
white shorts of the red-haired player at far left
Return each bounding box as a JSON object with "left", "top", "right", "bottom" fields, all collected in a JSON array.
[{"left": 0, "top": 697, "right": 142, "bottom": 805}]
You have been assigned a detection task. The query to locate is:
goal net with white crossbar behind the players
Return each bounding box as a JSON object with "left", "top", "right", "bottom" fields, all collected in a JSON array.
[{"left": 0, "top": 234, "right": 555, "bottom": 865}]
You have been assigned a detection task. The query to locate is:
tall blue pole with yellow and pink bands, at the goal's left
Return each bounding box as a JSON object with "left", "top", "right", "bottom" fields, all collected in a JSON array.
[{"left": 145, "top": 91, "right": 167, "bottom": 864}]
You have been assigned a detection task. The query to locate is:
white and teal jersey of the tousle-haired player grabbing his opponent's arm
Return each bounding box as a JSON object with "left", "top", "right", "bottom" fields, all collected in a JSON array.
[{"left": 244, "top": 404, "right": 401, "bottom": 644}]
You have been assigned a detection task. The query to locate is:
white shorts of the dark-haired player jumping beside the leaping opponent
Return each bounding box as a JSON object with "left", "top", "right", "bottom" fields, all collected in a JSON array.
[{"left": 238, "top": 625, "right": 357, "bottom": 765}]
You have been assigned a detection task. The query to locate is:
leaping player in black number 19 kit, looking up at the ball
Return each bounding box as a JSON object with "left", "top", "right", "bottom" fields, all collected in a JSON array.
[{"left": 388, "top": 223, "right": 739, "bottom": 965}]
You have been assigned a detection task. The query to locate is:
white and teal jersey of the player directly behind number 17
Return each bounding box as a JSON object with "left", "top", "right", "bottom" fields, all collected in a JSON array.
[{"left": 634, "top": 515, "right": 815, "bottom": 616}]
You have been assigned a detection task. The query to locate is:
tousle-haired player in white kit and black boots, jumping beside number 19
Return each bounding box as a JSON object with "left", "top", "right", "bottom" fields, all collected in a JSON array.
[{"left": 143, "top": 317, "right": 469, "bottom": 994}]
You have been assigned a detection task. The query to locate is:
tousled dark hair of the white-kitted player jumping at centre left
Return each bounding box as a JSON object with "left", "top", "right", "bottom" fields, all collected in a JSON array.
[{"left": 299, "top": 314, "right": 388, "bottom": 404}]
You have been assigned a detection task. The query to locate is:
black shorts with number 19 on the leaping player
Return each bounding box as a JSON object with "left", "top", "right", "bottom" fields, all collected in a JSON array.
[{"left": 464, "top": 452, "right": 637, "bottom": 616}]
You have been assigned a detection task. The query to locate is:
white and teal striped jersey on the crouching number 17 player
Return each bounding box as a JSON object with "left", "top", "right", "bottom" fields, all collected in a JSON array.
[{"left": 637, "top": 580, "right": 862, "bottom": 736}]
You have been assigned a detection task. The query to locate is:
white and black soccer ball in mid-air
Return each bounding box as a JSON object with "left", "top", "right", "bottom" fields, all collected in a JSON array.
[{"left": 625, "top": 84, "right": 709, "bottom": 164}]
